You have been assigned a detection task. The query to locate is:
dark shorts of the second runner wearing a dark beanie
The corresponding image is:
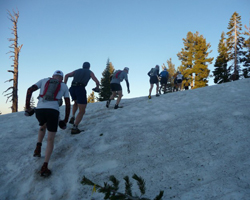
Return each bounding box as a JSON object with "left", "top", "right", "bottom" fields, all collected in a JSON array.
[{"left": 69, "top": 86, "right": 87, "bottom": 104}]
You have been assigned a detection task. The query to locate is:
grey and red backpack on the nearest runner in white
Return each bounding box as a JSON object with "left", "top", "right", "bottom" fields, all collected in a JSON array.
[{"left": 39, "top": 78, "right": 61, "bottom": 101}]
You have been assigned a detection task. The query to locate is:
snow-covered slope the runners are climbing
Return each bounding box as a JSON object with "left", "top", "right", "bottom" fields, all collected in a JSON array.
[{"left": 0, "top": 79, "right": 250, "bottom": 200}]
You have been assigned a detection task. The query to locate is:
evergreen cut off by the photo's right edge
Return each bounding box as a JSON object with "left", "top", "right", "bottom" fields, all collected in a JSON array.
[{"left": 242, "top": 22, "right": 250, "bottom": 78}]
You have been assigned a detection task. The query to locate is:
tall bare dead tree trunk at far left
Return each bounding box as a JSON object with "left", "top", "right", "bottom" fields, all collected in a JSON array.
[{"left": 4, "top": 10, "right": 23, "bottom": 112}]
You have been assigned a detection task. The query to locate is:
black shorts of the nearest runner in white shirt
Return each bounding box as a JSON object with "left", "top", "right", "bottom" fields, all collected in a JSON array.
[{"left": 36, "top": 109, "right": 59, "bottom": 132}]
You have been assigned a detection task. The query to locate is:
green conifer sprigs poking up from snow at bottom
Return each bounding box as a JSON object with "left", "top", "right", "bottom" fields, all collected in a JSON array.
[{"left": 81, "top": 174, "right": 164, "bottom": 200}]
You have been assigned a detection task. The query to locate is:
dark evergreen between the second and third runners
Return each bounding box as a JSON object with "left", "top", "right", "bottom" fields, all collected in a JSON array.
[{"left": 98, "top": 59, "right": 114, "bottom": 101}]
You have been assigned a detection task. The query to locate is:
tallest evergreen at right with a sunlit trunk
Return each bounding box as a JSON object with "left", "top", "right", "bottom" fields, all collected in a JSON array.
[{"left": 227, "top": 12, "right": 244, "bottom": 80}]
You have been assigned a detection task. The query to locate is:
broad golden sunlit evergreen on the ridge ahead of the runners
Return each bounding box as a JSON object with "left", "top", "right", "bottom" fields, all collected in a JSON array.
[{"left": 177, "top": 32, "right": 213, "bottom": 88}]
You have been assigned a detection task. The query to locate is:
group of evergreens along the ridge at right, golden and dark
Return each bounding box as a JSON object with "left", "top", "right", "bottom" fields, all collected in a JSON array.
[{"left": 162, "top": 12, "right": 250, "bottom": 89}]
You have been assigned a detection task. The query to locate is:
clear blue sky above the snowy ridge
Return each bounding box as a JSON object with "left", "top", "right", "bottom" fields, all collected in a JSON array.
[{"left": 0, "top": 0, "right": 250, "bottom": 114}]
